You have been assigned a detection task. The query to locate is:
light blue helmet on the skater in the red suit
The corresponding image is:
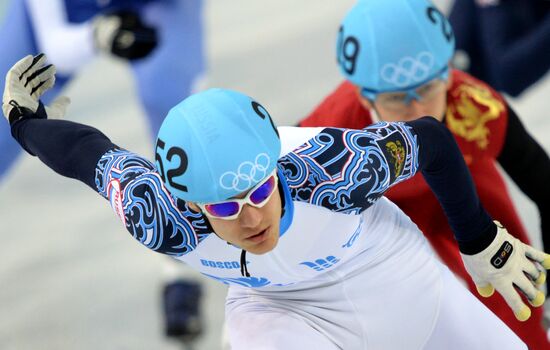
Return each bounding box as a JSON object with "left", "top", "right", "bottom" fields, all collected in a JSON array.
[{"left": 336, "top": 0, "right": 455, "bottom": 93}]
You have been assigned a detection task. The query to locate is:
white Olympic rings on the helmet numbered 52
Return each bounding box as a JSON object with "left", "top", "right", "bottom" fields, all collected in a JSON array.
[{"left": 220, "top": 153, "right": 271, "bottom": 192}]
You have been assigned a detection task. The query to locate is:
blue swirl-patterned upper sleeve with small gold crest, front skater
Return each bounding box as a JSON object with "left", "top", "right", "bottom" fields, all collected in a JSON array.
[{"left": 279, "top": 123, "right": 418, "bottom": 213}]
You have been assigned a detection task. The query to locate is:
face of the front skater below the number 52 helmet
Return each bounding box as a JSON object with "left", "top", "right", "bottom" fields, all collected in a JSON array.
[{"left": 189, "top": 175, "right": 282, "bottom": 254}]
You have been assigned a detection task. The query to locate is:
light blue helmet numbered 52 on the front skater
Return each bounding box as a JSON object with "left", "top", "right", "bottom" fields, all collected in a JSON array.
[{"left": 155, "top": 89, "right": 281, "bottom": 203}]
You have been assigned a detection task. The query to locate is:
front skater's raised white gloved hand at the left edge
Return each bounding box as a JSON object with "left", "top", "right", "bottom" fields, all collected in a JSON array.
[{"left": 2, "top": 54, "right": 70, "bottom": 124}]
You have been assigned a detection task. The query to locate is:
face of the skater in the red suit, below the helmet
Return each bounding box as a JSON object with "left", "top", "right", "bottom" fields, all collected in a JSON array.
[{"left": 356, "top": 69, "right": 451, "bottom": 122}]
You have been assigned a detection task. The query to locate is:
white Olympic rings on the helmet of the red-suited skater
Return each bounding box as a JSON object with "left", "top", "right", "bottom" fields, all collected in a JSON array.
[{"left": 380, "top": 51, "right": 435, "bottom": 88}]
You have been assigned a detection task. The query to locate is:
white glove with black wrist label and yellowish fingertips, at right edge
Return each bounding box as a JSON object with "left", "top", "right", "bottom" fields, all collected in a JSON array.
[{"left": 461, "top": 221, "right": 550, "bottom": 321}]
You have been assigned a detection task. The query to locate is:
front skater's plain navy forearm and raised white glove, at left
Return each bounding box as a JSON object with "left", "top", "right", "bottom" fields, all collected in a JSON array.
[{"left": 2, "top": 54, "right": 115, "bottom": 188}]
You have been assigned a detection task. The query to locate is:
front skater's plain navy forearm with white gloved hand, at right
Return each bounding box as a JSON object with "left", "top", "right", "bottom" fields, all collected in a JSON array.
[{"left": 409, "top": 119, "right": 550, "bottom": 321}]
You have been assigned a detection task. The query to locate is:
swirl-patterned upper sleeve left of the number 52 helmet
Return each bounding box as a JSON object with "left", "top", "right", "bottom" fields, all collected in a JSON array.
[{"left": 95, "top": 149, "right": 211, "bottom": 256}]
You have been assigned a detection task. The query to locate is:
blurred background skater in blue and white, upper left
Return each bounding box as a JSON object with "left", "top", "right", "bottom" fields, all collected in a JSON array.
[{"left": 0, "top": 0, "right": 205, "bottom": 342}]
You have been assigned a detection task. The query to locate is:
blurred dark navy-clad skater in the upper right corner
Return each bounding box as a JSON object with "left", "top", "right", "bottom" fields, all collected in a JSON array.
[{"left": 449, "top": 0, "right": 550, "bottom": 97}]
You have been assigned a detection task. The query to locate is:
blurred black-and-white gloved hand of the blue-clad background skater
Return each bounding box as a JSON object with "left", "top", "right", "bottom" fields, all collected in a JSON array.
[{"left": 93, "top": 11, "right": 158, "bottom": 60}]
